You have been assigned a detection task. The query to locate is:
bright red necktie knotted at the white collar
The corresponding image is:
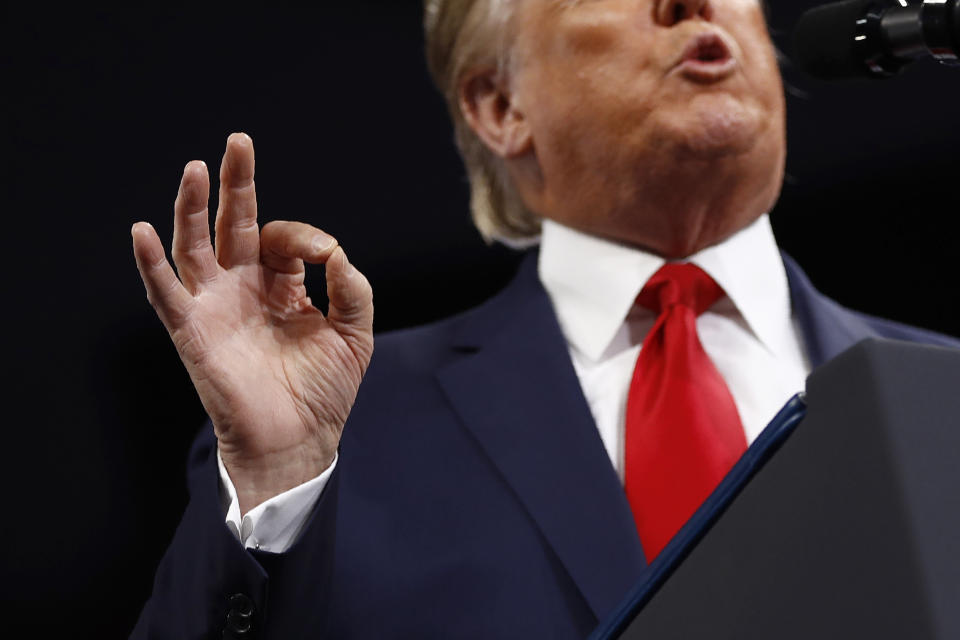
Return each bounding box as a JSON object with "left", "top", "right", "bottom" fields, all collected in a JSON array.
[{"left": 625, "top": 264, "right": 747, "bottom": 562}]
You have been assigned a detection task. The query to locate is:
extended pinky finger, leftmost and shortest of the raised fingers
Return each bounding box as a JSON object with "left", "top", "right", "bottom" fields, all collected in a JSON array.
[{"left": 130, "top": 222, "right": 193, "bottom": 331}]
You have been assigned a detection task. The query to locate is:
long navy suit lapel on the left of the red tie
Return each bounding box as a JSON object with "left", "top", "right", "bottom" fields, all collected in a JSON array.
[{"left": 438, "top": 252, "right": 644, "bottom": 619}]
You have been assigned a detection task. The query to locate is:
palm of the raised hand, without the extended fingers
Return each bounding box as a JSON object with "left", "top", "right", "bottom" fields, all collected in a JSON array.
[{"left": 171, "top": 265, "right": 366, "bottom": 453}]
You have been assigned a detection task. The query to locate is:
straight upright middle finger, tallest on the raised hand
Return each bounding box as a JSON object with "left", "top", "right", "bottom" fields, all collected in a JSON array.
[{"left": 216, "top": 133, "right": 260, "bottom": 269}]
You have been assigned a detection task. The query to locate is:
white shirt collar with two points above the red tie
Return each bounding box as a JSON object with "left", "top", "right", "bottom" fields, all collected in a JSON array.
[{"left": 538, "top": 215, "right": 790, "bottom": 361}]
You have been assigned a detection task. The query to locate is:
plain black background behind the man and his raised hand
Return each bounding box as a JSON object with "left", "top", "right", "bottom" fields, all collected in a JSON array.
[{"left": 0, "top": 0, "right": 960, "bottom": 638}]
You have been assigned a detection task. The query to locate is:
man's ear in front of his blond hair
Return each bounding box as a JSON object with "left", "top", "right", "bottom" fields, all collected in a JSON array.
[{"left": 459, "top": 68, "right": 533, "bottom": 159}]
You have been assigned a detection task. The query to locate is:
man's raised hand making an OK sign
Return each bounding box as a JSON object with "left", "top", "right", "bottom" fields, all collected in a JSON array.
[{"left": 132, "top": 134, "right": 373, "bottom": 513}]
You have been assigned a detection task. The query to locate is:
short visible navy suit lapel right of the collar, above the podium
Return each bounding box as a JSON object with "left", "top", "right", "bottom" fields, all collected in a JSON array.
[{"left": 781, "top": 253, "right": 880, "bottom": 368}]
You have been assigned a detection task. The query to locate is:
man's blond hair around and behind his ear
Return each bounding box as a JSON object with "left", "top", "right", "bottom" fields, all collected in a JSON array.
[{"left": 423, "top": 0, "right": 540, "bottom": 244}]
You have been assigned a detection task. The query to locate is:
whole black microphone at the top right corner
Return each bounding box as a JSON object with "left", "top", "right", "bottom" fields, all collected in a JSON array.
[{"left": 793, "top": 0, "right": 960, "bottom": 79}]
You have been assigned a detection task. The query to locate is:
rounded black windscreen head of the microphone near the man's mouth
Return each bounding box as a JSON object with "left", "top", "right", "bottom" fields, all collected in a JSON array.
[{"left": 793, "top": 0, "right": 877, "bottom": 79}]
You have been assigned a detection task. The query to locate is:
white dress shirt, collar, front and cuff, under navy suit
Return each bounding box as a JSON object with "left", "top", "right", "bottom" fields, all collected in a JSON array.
[{"left": 217, "top": 216, "right": 810, "bottom": 553}]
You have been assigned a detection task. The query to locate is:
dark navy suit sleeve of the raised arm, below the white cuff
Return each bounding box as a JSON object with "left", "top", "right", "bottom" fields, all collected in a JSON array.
[{"left": 131, "top": 425, "right": 340, "bottom": 640}]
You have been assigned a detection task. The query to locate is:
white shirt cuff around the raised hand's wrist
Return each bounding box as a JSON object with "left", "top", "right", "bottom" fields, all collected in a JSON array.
[{"left": 217, "top": 448, "right": 340, "bottom": 553}]
